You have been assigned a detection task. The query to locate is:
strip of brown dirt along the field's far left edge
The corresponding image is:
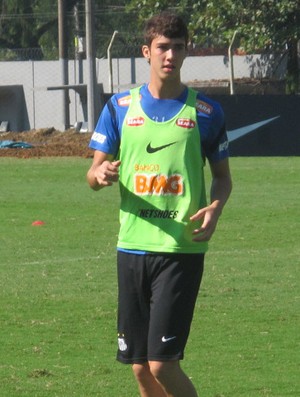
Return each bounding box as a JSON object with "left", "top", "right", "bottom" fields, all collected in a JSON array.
[{"left": 0, "top": 128, "right": 93, "bottom": 158}]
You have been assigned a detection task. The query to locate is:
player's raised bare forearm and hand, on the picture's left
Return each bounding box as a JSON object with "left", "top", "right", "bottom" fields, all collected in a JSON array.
[{"left": 87, "top": 150, "right": 121, "bottom": 190}]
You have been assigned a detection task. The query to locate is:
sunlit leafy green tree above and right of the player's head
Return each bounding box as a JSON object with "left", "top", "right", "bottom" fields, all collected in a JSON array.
[{"left": 128, "top": 0, "right": 300, "bottom": 93}]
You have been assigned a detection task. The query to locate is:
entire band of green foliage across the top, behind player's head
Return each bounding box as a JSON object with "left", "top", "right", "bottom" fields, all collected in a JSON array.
[{"left": 0, "top": 0, "right": 300, "bottom": 86}]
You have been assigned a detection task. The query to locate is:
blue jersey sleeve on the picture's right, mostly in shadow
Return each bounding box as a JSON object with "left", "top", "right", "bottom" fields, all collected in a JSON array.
[{"left": 197, "top": 94, "right": 229, "bottom": 163}]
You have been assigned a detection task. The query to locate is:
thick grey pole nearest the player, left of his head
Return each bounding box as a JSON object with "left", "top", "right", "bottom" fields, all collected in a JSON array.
[{"left": 85, "top": 0, "right": 96, "bottom": 132}]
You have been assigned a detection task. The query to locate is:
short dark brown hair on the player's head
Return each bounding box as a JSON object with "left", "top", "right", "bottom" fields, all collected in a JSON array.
[{"left": 144, "top": 12, "right": 189, "bottom": 46}]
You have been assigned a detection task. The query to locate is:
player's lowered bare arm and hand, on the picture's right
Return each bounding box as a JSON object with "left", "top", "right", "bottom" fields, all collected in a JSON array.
[{"left": 190, "top": 159, "right": 232, "bottom": 241}]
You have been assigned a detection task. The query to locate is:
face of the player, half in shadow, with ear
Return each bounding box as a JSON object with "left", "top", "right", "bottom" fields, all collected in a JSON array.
[{"left": 143, "top": 36, "right": 186, "bottom": 79}]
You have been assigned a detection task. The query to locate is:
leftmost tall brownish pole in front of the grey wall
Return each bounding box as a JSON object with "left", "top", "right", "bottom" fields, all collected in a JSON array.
[{"left": 58, "top": 0, "right": 70, "bottom": 130}]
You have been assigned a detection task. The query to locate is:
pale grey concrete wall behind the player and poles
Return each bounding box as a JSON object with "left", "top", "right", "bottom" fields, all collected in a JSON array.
[{"left": 0, "top": 55, "right": 285, "bottom": 131}]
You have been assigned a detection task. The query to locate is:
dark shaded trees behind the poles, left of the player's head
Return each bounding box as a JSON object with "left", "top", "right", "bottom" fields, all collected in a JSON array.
[{"left": 0, "top": 0, "right": 135, "bottom": 59}]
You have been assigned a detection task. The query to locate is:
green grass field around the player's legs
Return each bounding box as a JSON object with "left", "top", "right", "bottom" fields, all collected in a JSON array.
[{"left": 0, "top": 158, "right": 300, "bottom": 397}]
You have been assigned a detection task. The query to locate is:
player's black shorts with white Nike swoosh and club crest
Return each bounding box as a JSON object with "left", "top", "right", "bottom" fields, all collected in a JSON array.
[{"left": 117, "top": 252, "right": 204, "bottom": 364}]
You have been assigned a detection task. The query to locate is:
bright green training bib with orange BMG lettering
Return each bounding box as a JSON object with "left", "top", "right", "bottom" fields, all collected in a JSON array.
[{"left": 118, "top": 88, "right": 207, "bottom": 253}]
